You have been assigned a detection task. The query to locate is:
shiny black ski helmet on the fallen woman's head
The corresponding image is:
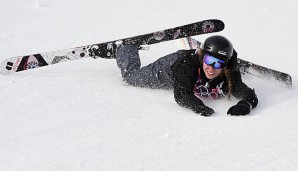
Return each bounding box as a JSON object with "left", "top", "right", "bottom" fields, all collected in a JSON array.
[{"left": 201, "top": 35, "right": 233, "bottom": 60}]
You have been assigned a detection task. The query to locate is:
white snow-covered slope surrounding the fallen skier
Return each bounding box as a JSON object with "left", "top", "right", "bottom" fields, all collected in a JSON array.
[{"left": 0, "top": 0, "right": 298, "bottom": 171}]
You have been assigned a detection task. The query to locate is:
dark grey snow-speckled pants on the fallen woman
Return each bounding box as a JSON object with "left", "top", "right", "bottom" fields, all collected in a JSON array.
[{"left": 116, "top": 45, "right": 179, "bottom": 89}]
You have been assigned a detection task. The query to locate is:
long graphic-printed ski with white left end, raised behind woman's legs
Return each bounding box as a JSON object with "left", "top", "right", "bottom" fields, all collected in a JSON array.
[{"left": 0, "top": 19, "right": 224, "bottom": 74}]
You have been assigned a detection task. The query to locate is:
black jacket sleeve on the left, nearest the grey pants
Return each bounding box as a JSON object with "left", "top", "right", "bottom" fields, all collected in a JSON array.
[{"left": 172, "top": 53, "right": 204, "bottom": 112}]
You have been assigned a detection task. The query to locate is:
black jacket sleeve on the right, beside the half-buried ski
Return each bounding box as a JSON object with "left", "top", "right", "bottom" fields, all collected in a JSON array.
[{"left": 232, "top": 71, "right": 258, "bottom": 108}]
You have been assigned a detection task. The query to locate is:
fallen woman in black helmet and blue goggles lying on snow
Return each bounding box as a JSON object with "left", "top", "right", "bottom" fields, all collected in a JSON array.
[{"left": 116, "top": 36, "right": 258, "bottom": 116}]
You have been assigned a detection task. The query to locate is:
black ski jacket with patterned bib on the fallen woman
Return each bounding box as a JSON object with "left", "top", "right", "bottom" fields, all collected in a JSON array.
[{"left": 171, "top": 50, "right": 258, "bottom": 111}]
